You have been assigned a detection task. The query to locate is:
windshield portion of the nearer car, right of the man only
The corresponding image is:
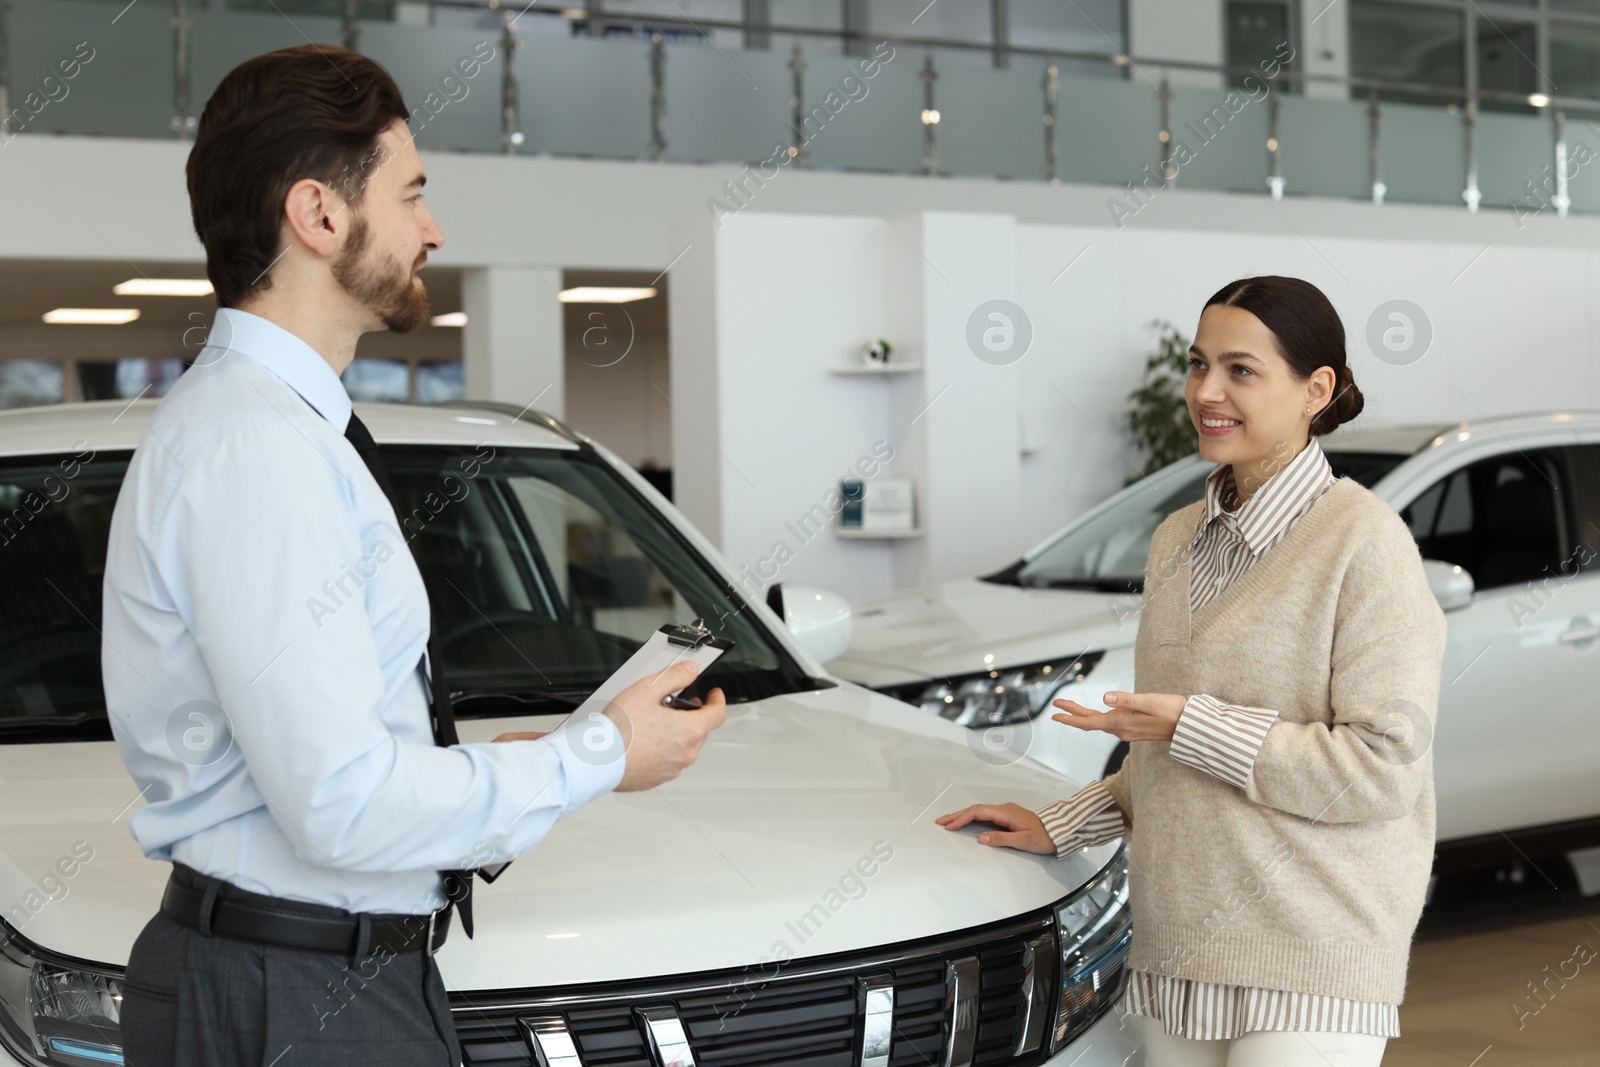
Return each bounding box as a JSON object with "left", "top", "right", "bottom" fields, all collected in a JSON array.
[{"left": 384, "top": 446, "right": 795, "bottom": 701}]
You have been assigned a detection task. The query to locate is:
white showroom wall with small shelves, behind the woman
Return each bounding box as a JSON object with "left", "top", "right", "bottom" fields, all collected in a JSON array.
[{"left": 672, "top": 202, "right": 1600, "bottom": 598}]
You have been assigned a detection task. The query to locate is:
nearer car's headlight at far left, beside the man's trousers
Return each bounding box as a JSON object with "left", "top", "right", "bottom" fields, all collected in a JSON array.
[{"left": 0, "top": 925, "right": 123, "bottom": 1067}]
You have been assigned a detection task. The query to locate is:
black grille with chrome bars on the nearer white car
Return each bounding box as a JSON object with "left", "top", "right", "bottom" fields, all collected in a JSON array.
[{"left": 451, "top": 912, "right": 1120, "bottom": 1067}]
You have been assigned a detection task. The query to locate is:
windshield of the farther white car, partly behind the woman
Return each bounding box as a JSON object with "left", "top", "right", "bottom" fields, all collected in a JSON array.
[{"left": 987, "top": 451, "right": 1406, "bottom": 593}]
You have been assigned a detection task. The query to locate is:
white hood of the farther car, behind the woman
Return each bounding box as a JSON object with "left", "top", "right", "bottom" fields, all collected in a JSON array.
[{"left": 827, "top": 577, "right": 1141, "bottom": 686}]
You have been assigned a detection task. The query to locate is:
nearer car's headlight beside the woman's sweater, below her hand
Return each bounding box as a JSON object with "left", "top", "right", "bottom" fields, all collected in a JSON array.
[{"left": 1053, "top": 845, "right": 1133, "bottom": 1049}]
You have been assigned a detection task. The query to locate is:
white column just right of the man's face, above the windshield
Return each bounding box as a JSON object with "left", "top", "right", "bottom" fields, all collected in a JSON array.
[{"left": 461, "top": 267, "right": 566, "bottom": 418}]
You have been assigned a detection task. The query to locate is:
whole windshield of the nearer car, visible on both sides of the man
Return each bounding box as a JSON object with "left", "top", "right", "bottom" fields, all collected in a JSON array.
[{"left": 0, "top": 445, "right": 824, "bottom": 742}]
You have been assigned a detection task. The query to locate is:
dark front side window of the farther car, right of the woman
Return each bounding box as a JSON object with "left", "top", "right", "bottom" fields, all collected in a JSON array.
[{"left": 1400, "top": 448, "right": 1571, "bottom": 589}]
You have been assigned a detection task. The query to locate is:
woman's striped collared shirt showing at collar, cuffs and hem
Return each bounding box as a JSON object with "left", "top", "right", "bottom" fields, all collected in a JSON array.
[{"left": 1038, "top": 438, "right": 1400, "bottom": 1041}]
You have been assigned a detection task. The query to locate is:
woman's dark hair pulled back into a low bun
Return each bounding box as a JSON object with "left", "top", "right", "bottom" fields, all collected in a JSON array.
[{"left": 1202, "top": 274, "right": 1363, "bottom": 437}]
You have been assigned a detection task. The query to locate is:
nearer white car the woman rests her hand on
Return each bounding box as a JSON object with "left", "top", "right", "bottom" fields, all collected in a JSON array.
[{"left": 0, "top": 402, "right": 1142, "bottom": 1067}]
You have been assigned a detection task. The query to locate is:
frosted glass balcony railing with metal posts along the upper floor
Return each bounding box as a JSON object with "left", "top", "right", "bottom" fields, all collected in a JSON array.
[{"left": 0, "top": 0, "right": 1600, "bottom": 218}]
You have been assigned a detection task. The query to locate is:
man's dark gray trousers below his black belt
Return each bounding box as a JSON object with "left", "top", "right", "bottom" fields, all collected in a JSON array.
[{"left": 122, "top": 905, "right": 461, "bottom": 1067}]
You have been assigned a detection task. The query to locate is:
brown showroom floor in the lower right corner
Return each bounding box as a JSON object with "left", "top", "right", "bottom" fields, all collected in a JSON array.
[{"left": 1384, "top": 912, "right": 1600, "bottom": 1067}]
